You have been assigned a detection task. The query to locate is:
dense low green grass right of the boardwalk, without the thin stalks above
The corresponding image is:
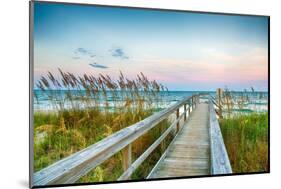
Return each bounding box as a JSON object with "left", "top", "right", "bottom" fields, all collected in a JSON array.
[{"left": 220, "top": 113, "right": 268, "bottom": 173}]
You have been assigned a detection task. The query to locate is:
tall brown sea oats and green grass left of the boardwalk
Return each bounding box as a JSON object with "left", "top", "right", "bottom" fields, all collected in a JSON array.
[{"left": 34, "top": 69, "right": 171, "bottom": 182}]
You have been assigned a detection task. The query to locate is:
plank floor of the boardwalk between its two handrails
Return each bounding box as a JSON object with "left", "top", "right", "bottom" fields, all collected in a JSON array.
[{"left": 148, "top": 103, "right": 210, "bottom": 178}]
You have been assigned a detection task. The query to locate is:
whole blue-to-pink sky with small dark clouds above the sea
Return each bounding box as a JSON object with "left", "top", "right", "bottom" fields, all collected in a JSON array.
[{"left": 34, "top": 2, "right": 268, "bottom": 91}]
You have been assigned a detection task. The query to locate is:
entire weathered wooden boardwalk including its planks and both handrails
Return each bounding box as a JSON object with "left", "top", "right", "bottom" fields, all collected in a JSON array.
[{"left": 31, "top": 94, "right": 232, "bottom": 186}]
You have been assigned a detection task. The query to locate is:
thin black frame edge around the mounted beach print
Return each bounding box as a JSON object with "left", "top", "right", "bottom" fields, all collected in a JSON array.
[{"left": 29, "top": 1, "right": 270, "bottom": 188}]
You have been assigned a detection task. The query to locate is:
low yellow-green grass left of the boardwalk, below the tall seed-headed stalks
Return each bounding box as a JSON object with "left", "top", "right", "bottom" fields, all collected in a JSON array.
[{"left": 34, "top": 110, "right": 171, "bottom": 182}]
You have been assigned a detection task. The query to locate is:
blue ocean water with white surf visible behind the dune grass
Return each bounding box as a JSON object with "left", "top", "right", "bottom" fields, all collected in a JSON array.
[{"left": 33, "top": 90, "right": 268, "bottom": 111}]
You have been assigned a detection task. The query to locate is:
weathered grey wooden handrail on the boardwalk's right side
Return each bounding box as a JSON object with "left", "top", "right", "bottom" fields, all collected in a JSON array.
[{"left": 209, "top": 97, "right": 232, "bottom": 174}]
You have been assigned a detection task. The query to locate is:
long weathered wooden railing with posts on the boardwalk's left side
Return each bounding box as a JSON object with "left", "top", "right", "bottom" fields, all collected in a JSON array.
[{"left": 33, "top": 95, "right": 199, "bottom": 186}]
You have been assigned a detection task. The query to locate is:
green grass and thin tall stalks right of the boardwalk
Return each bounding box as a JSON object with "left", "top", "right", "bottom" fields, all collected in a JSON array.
[{"left": 219, "top": 87, "right": 268, "bottom": 173}]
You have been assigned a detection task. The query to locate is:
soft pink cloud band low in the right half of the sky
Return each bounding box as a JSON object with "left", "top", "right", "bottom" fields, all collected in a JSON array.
[{"left": 127, "top": 48, "right": 268, "bottom": 87}]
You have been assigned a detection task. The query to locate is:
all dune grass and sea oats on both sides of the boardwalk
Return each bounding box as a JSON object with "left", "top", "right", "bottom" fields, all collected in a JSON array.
[{"left": 34, "top": 72, "right": 268, "bottom": 182}]
